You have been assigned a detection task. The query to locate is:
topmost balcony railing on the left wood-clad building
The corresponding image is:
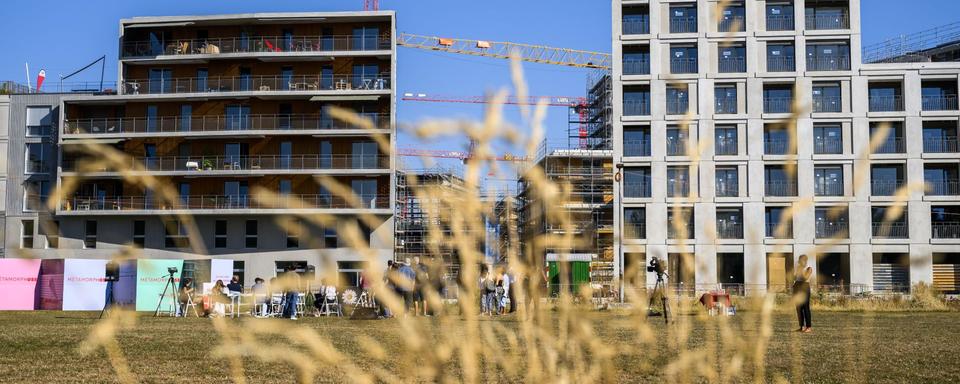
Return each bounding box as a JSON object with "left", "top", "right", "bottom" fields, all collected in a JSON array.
[{"left": 122, "top": 35, "right": 393, "bottom": 58}]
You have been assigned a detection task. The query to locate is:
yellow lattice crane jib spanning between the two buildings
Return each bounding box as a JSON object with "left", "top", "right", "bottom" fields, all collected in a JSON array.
[{"left": 397, "top": 33, "right": 612, "bottom": 70}]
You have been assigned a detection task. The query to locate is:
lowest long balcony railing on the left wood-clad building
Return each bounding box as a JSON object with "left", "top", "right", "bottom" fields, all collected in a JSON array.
[{"left": 61, "top": 194, "right": 390, "bottom": 212}]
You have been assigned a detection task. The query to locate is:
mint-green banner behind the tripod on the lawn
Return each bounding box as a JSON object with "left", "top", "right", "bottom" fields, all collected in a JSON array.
[{"left": 137, "top": 259, "right": 183, "bottom": 312}]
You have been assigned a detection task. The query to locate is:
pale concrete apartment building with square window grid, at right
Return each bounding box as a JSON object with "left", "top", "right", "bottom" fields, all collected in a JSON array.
[{"left": 612, "top": 0, "right": 960, "bottom": 293}]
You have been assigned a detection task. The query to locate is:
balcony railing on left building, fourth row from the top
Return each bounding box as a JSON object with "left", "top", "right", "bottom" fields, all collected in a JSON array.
[{"left": 62, "top": 155, "right": 390, "bottom": 172}]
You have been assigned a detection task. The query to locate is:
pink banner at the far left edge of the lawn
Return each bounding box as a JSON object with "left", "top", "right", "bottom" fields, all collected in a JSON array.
[{"left": 0, "top": 259, "right": 40, "bottom": 311}]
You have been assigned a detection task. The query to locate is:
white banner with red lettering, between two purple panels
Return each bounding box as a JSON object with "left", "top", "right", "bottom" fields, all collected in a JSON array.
[{"left": 63, "top": 259, "right": 108, "bottom": 311}]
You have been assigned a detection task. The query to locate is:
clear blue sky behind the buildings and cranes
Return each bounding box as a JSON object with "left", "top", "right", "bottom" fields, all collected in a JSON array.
[{"left": 0, "top": 0, "right": 960, "bottom": 167}]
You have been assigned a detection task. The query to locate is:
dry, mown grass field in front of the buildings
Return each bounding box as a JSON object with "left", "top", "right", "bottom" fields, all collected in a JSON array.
[{"left": 0, "top": 311, "right": 960, "bottom": 383}]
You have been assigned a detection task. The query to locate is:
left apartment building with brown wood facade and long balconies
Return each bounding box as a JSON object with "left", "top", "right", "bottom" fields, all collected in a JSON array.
[{"left": 7, "top": 11, "right": 396, "bottom": 285}]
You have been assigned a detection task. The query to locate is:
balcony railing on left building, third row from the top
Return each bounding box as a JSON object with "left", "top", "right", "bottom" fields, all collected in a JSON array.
[{"left": 63, "top": 113, "right": 390, "bottom": 134}]
